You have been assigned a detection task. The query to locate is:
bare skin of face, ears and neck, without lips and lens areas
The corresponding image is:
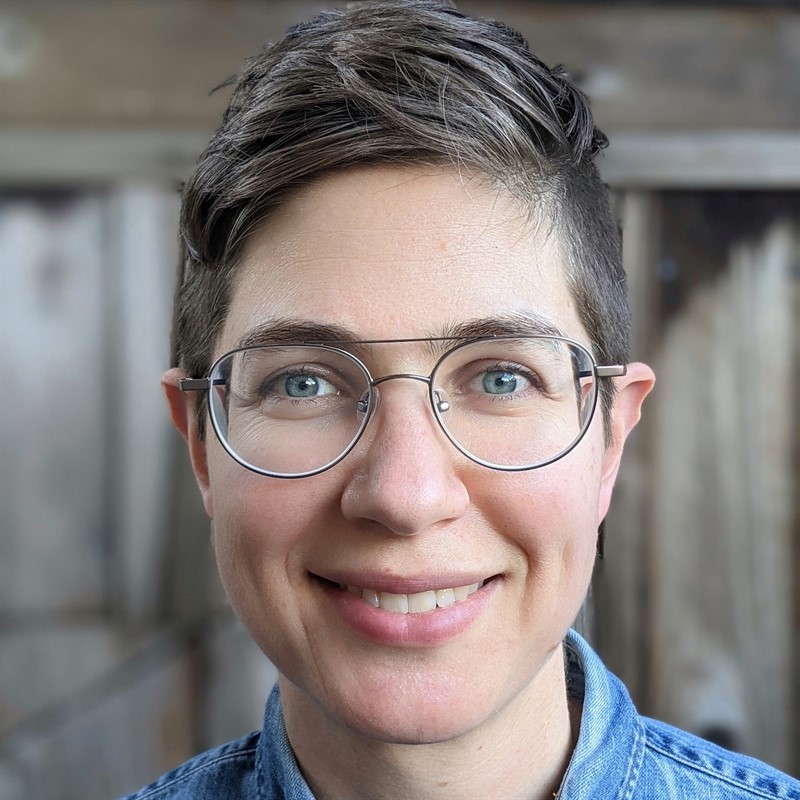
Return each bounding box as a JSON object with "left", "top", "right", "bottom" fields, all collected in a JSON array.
[{"left": 164, "top": 167, "right": 653, "bottom": 800}]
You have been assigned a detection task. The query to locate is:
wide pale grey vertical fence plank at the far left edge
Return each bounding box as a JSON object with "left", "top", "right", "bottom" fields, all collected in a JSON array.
[{"left": 0, "top": 193, "right": 108, "bottom": 614}]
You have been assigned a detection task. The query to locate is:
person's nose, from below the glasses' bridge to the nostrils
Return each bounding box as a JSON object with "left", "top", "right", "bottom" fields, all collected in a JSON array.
[{"left": 341, "top": 376, "right": 469, "bottom": 536}]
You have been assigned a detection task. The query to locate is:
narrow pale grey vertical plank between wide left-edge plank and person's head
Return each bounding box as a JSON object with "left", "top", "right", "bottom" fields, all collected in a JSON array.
[{"left": 107, "top": 183, "right": 178, "bottom": 624}]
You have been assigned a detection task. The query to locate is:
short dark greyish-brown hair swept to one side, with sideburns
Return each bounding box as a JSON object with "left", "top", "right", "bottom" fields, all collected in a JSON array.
[{"left": 173, "top": 0, "right": 630, "bottom": 434}]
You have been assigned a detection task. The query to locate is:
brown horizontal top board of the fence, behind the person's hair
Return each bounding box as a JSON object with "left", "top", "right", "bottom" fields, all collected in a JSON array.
[{"left": 0, "top": 0, "right": 800, "bottom": 132}]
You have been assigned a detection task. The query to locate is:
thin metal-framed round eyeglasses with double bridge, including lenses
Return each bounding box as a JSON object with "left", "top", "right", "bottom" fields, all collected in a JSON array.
[{"left": 180, "top": 336, "right": 626, "bottom": 478}]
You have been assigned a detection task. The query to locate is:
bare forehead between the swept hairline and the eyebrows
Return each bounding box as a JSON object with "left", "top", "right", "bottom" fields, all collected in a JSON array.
[{"left": 219, "top": 167, "right": 585, "bottom": 352}]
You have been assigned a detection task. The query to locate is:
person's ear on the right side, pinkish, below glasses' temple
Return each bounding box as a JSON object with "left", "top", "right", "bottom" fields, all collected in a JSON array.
[{"left": 597, "top": 362, "right": 656, "bottom": 526}]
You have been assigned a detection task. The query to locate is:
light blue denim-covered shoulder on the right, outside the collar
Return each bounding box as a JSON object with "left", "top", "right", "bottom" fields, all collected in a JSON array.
[{"left": 635, "top": 717, "right": 800, "bottom": 800}]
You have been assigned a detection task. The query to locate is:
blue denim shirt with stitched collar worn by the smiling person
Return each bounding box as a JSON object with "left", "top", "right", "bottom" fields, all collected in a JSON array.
[{"left": 126, "top": 631, "right": 800, "bottom": 800}]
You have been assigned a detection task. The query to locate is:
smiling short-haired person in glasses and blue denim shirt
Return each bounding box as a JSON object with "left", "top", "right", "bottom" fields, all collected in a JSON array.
[{"left": 122, "top": 2, "right": 800, "bottom": 800}]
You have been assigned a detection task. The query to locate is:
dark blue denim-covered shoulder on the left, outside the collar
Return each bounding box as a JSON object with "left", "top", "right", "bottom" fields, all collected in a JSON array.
[{"left": 123, "top": 732, "right": 259, "bottom": 800}]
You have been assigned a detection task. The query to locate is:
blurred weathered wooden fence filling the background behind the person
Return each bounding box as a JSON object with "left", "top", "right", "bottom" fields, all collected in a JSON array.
[{"left": 0, "top": 0, "right": 800, "bottom": 800}]
